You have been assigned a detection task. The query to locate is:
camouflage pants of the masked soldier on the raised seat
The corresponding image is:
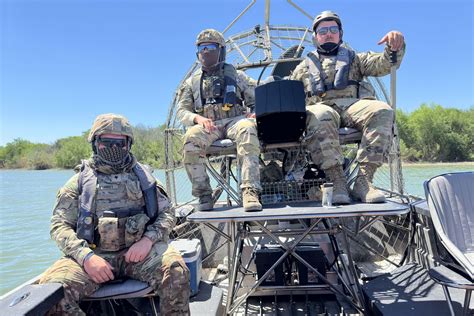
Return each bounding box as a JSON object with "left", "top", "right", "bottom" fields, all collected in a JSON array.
[{"left": 183, "top": 116, "right": 261, "bottom": 197}]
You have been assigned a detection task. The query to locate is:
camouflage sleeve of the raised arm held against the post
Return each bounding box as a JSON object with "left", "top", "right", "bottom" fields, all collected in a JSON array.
[{"left": 355, "top": 45, "right": 405, "bottom": 77}]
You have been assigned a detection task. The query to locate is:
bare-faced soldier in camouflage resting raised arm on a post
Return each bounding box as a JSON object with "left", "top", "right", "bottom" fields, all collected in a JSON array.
[{"left": 290, "top": 11, "right": 405, "bottom": 204}]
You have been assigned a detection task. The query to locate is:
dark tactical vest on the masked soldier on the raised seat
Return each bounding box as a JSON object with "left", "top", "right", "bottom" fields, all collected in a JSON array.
[{"left": 191, "top": 64, "right": 244, "bottom": 121}]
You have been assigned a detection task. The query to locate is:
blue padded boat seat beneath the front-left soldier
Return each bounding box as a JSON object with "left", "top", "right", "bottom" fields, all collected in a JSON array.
[{"left": 84, "top": 279, "right": 153, "bottom": 301}]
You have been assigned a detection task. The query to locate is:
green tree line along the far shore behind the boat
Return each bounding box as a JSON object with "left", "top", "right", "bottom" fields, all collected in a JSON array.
[{"left": 0, "top": 104, "right": 474, "bottom": 170}]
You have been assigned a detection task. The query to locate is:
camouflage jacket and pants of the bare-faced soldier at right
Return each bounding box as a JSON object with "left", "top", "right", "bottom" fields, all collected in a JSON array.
[{"left": 290, "top": 43, "right": 405, "bottom": 169}]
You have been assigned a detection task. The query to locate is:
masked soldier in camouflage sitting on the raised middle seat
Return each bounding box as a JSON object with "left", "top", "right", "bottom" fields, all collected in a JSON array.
[{"left": 177, "top": 29, "right": 262, "bottom": 211}]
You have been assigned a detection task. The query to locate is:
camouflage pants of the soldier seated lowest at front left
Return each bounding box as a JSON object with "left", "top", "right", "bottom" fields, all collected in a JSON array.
[{"left": 39, "top": 242, "right": 190, "bottom": 315}]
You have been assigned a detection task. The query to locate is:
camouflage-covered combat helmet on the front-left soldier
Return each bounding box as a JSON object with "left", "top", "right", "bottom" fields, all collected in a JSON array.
[{"left": 87, "top": 113, "right": 133, "bottom": 144}]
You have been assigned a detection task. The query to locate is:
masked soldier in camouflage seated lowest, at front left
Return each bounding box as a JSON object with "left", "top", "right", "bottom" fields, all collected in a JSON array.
[{"left": 40, "top": 114, "right": 190, "bottom": 315}]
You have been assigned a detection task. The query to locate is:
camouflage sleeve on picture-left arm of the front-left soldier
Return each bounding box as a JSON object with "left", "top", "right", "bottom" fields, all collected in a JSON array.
[{"left": 50, "top": 174, "right": 92, "bottom": 265}]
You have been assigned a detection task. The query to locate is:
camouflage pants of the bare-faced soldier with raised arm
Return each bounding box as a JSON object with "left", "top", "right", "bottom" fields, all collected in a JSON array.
[{"left": 306, "top": 99, "right": 393, "bottom": 170}]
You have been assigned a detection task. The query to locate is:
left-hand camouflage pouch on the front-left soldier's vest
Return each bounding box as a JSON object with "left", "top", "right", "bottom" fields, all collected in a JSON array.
[{"left": 98, "top": 217, "right": 127, "bottom": 251}]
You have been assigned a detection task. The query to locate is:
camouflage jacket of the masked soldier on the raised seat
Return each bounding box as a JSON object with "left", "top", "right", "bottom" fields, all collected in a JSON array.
[{"left": 176, "top": 64, "right": 257, "bottom": 126}]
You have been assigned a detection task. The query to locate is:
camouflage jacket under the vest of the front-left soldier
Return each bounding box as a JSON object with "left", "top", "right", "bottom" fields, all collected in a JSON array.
[{"left": 50, "top": 159, "right": 176, "bottom": 265}]
